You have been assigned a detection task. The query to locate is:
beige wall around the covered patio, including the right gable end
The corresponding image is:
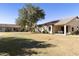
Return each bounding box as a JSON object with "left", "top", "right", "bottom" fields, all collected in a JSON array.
[{"left": 53, "top": 18, "right": 79, "bottom": 33}]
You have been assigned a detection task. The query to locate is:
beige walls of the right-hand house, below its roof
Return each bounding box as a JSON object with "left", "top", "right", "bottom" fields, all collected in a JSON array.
[{"left": 36, "top": 18, "right": 79, "bottom": 33}]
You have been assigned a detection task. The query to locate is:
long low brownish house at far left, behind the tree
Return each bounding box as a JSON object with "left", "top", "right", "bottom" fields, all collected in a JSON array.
[{"left": 0, "top": 24, "right": 21, "bottom": 32}]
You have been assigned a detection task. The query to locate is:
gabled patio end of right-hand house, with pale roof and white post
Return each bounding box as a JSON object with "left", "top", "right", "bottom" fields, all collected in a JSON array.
[{"left": 54, "top": 16, "right": 79, "bottom": 35}]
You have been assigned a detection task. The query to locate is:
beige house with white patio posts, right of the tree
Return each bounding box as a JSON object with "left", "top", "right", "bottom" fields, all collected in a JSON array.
[{"left": 35, "top": 16, "right": 79, "bottom": 35}]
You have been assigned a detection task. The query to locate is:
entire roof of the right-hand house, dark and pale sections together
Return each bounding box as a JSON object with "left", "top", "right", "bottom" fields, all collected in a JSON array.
[{"left": 38, "top": 16, "right": 79, "bottom": 26}]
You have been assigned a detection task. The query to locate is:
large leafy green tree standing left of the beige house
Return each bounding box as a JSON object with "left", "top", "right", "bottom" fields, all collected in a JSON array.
[{"left": 16, "top": 4, "right": 45, "bottom": 31}]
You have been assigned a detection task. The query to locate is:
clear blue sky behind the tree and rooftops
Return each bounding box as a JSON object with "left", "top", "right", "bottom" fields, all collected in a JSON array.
[{"left": 0, "top": 3, "right": 79, "bottom": 24}]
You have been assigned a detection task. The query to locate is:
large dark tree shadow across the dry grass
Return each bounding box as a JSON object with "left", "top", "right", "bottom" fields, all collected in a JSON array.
[{"left": 0, "top": 37, "right": 56, "bottom": 56}]
